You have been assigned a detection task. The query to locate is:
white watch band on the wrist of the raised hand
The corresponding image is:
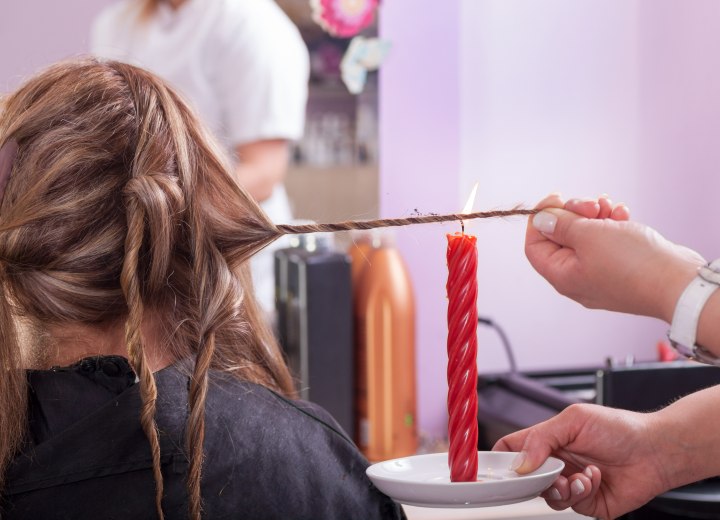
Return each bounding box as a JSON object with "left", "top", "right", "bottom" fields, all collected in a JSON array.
[{"left": 668, "top": 259, "right": 720, "bottom": 365}]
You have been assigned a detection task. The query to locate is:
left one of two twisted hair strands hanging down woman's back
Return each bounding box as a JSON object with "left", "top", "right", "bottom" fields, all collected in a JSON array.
[{"left": 120, "top": 196, "right": 164, "bottom": 520}]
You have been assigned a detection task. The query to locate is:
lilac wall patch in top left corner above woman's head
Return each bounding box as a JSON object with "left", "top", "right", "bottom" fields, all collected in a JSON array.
[{"left": 0, "top": 0, "right": 111, "bottom": 93}]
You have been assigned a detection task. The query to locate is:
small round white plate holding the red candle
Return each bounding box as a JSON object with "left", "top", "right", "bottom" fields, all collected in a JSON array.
[{"left": 367, "top": 451, "right": 565, "bottom": 508}]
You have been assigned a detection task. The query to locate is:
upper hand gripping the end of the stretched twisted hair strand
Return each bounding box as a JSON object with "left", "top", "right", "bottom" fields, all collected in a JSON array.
[{"left": 525, "top": 195, "right": 705, "bottom": 322}]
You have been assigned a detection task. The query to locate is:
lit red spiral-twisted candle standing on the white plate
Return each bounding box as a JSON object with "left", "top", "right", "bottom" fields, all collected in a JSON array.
[{"left": 447, "top": 233, "right": 478, "bottom": 482}]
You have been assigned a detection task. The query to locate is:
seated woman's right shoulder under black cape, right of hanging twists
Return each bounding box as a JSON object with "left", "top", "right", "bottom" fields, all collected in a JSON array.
[{"left": 188, "top": 372, "right": 402, "bottom": 519}]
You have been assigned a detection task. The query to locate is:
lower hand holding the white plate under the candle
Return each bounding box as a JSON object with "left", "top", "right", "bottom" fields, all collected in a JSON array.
[{"left": 493, "top": 404, "right": 672, "bottom": 519}]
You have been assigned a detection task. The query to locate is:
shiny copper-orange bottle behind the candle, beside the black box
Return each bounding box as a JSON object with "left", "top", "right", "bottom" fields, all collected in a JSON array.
[{"left": 350, "top": 234, "right": 418, "bottom": 461}]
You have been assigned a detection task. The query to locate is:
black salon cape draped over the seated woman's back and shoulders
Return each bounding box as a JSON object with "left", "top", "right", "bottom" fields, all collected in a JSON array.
[{"left": 1, "top": 356, "right": 404, "bottom": 520}]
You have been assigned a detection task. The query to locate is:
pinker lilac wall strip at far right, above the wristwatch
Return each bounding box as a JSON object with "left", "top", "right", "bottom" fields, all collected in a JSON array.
[{"left": 639, "top": 0, "right": 720, "bottom": 252}]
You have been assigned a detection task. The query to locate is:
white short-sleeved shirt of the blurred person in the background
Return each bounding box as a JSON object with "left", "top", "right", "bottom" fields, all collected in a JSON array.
[{"left": 91, "top": 0, "right": 309, "bottom": 312}]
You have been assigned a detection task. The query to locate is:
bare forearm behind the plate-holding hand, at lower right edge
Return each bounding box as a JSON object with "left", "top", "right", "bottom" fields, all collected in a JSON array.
[{"left": 648, "top": 386, "right": 720, "bottom": 489}]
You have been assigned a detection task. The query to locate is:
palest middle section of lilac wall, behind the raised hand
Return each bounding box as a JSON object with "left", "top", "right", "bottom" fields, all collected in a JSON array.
[{"left": 460, "top": 0, "right": 658, "bottom": 378}]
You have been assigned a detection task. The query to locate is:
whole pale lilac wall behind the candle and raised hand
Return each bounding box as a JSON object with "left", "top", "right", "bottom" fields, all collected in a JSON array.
[{"left": 381, "top": 0, "right": 720, "bottom": 435}]
